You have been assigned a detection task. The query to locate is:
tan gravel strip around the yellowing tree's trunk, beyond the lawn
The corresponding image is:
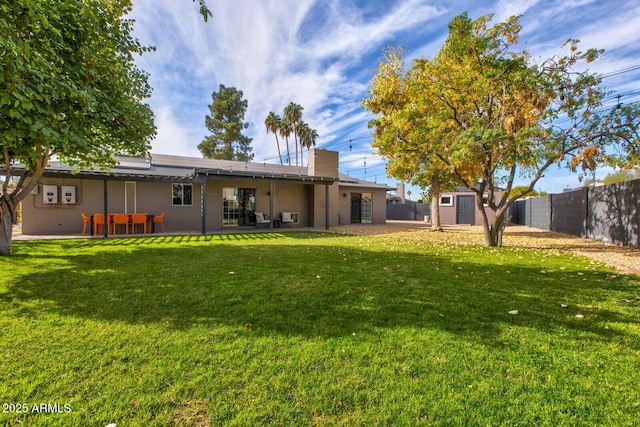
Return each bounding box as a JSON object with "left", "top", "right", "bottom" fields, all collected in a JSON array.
[{"left": 330, "top": 221, "right": 640, "bottom": 276}]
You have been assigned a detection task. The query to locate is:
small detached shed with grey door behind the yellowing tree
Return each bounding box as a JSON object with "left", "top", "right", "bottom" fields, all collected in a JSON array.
[{"left": 439, "top": 186, "right": 501, "bottom": 225}]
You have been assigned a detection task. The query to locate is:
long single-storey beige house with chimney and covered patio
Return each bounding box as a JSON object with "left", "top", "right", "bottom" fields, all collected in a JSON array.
[{"left": 22, "top": 149, "right": 393, "bottom": 235}]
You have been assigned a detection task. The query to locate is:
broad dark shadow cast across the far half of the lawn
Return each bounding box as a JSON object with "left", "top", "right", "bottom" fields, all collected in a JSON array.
[{"left": 0, "top": 233, "right": 640, "bottom": 347}]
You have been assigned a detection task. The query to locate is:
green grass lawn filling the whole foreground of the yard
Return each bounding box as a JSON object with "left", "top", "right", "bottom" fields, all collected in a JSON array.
[{"left": 0, "top": 233, "right": 640, "bottom": 427}]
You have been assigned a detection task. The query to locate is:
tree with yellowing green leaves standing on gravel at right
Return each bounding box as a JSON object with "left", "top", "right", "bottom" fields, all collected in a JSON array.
[{"left": 364, "top": 14, "right": 639, "bottom": 246}]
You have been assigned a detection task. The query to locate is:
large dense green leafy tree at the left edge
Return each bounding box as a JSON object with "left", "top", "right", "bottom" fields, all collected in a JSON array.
[{"left": 0, "top": 0, "right": 155, "bottom": 255}]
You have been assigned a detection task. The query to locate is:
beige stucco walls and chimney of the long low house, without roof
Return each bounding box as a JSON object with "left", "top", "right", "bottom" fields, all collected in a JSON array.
[{"left": 22, "top": 150, "right": 386, "bottom": 235}]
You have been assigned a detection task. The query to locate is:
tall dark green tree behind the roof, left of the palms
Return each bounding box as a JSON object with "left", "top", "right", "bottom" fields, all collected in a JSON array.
[{"left": 198, "top": 84, "right": 253, "bottom": 162}]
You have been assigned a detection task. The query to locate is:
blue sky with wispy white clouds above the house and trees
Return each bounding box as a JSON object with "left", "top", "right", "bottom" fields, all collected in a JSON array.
[{"left": 130, "top": 0, "right": 640, "bottom": 199}]
